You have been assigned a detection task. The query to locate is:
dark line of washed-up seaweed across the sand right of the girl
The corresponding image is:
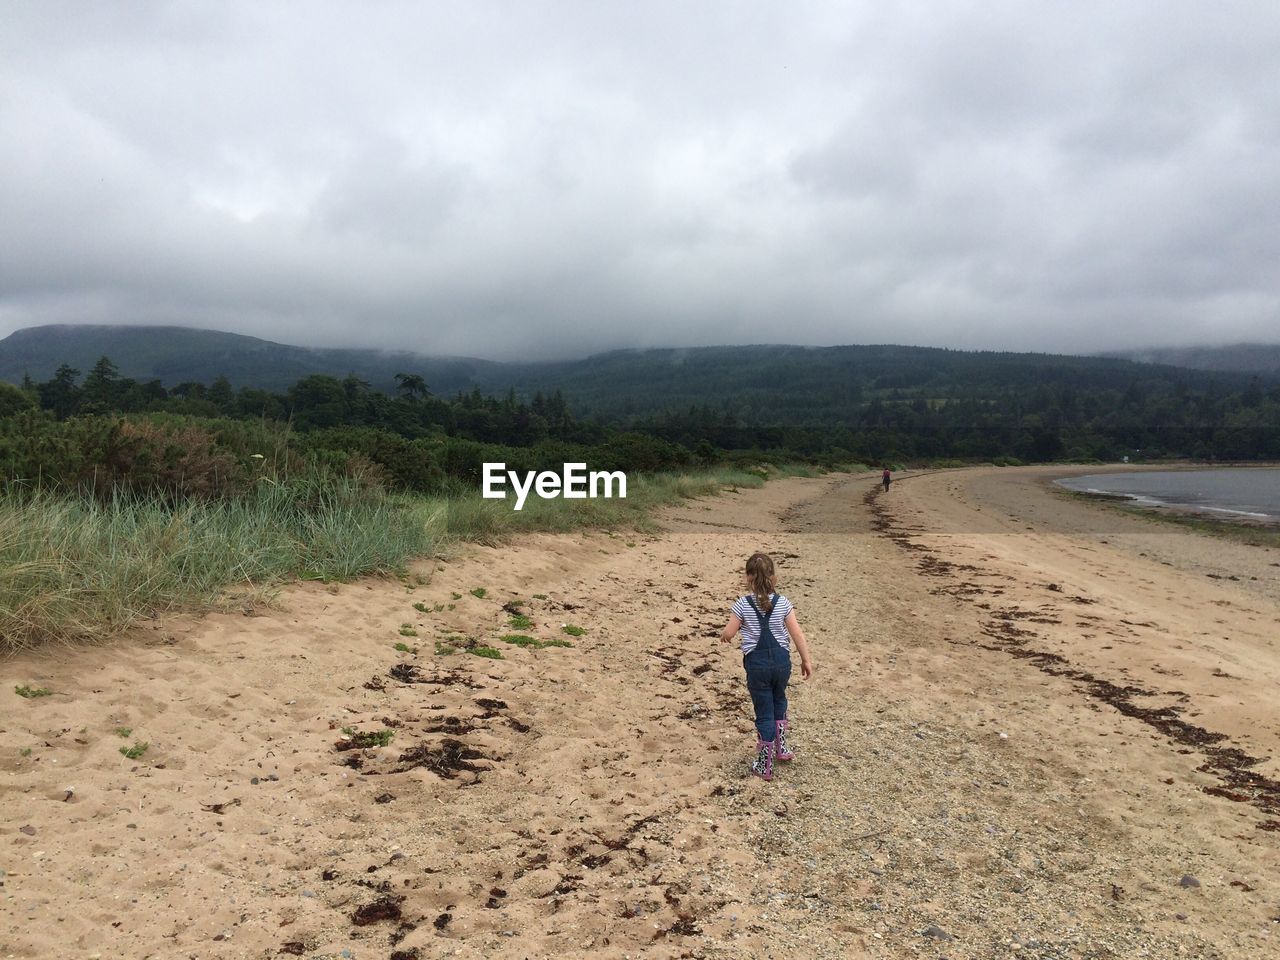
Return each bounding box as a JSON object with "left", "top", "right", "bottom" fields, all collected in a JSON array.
[{"left": 863, "top": 488, "right": 1280, "bottom": 829}]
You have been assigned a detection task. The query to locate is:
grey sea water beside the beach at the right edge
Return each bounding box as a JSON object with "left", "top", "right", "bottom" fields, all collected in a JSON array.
[{"left": 1056, "top": 467, "right": 1280, "bottom": 522}]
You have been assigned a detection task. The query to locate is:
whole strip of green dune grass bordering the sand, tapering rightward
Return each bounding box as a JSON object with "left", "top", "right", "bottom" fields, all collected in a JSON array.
[{"left": 0, "top": 468, "right": 829, "bottom": 653}]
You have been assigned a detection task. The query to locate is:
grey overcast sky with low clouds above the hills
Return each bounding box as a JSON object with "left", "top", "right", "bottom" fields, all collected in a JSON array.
[{"left": 0, "top": 0, "right": 1280, "bottom": 358}]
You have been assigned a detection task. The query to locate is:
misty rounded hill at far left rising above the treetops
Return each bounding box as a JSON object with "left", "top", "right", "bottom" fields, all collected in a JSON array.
[{"left": 0, "top": 325, "right": 498, "bottom": 394}]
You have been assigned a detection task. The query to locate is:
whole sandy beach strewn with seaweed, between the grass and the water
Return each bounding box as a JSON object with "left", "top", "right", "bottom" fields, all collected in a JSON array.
[{"left": 0, "top": 468, "right": 1280, "bottom": 960}]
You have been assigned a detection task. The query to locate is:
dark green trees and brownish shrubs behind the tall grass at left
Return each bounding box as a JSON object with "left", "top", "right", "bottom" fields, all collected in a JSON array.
[{"left": 0, "top": 357, "right": 732, "bottom": 499}]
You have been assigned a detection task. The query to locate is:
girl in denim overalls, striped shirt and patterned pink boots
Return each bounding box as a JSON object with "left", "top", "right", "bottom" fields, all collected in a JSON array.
[{"left": 721, "top": 553, "right": 813, "bottom": 780}]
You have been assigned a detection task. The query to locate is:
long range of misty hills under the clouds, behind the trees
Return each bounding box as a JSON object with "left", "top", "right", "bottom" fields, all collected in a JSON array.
[{"left": 0, "top": 326, "right": 1249, "bottom": 425}]
